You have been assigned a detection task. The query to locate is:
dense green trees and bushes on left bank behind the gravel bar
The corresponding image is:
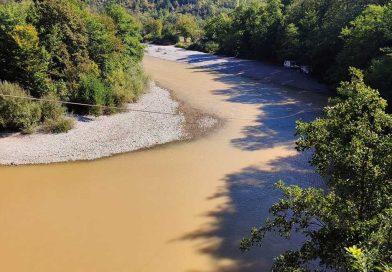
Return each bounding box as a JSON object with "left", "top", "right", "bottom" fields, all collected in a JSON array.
[{"left": 0, "top": 0, "right": 146, "bottom": 132}]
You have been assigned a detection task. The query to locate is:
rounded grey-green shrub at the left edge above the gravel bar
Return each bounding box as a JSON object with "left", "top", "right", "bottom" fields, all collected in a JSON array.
[{"left": 0, "top": 81, "right": 41, "bottom": 131}]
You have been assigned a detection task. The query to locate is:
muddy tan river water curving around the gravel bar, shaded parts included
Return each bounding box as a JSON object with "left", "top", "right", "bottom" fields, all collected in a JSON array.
[{"left": 0, "top": 57, "right": 320, "bottom": 272}]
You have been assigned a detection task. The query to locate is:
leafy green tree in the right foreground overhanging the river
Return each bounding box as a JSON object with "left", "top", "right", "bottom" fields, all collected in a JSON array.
[{"left": 241, "top": 69, "right": 392, "bottom": 271}]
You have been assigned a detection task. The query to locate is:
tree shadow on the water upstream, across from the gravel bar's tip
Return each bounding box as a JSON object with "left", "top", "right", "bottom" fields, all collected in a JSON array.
[{"left": 214, "top": 76, "right": 325, "bottom": 151}]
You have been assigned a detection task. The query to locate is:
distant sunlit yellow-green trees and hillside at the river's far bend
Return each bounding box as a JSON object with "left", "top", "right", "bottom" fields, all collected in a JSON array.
[{"left": 85, "top": 0, "right": 239, "bottom": 44}]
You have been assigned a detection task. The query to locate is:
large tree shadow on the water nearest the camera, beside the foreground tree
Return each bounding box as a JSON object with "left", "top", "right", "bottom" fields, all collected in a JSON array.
[{"left": 179, "top": 153, "right": 323, "bottom": 272}]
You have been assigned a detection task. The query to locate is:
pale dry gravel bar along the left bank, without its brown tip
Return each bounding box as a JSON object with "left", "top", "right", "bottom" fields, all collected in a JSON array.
[{"left": 0, "top": 84, "right": 190, "bottom": 165}]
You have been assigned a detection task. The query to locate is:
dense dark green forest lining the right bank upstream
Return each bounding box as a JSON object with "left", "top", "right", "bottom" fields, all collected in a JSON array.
[{"left": 139, "top": 0, "right": 392, "bottom": 105}]
